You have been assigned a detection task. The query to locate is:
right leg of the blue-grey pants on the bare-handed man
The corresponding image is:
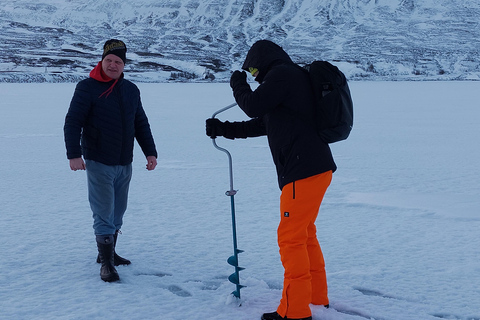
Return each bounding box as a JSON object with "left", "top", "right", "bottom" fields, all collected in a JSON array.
[{"left": 113, "top": 164, "right": 132, "bottom": 230}]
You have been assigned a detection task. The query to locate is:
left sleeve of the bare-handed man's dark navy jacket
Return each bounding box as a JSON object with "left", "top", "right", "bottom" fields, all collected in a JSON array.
[{"left": 63, "top": 82, "right": 91, "bottom": 159}]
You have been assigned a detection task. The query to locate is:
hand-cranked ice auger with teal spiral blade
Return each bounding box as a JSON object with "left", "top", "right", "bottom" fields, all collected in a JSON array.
[{"left": 212, "top": 103, "right": 245, "bottom": 299}]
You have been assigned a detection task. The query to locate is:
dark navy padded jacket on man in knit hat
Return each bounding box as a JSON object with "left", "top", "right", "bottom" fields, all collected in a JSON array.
[{"left": 64, "top": 75, "right": 157, "bottom": 165}]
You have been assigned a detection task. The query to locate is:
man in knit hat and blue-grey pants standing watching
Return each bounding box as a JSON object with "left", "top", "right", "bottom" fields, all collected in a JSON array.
[{"left": 64, "top": 39, "right": 157, "bottom": 282}]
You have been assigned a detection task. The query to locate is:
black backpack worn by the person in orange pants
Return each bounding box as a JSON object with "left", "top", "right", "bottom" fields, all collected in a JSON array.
[{"left": 304, "top": 61, "right": 353, "bottom": 143}]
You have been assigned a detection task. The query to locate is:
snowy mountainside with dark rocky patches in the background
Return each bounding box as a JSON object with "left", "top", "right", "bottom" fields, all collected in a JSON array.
[{"left": 0, "top": 0, "right": 480, "bottom": 82}]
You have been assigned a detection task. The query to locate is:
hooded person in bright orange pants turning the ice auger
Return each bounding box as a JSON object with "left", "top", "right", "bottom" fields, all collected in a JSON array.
[{"left": 206, "top": 40, "right": 336, "bottom": 320}]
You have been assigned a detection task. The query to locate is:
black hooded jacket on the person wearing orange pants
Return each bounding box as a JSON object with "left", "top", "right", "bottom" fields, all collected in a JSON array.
[{"left": 225, "top": 40, "right": 337, "bottom": 189}]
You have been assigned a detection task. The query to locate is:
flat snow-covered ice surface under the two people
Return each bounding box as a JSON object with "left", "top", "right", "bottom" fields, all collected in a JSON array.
[{"left": 0, "top": 82, "right": 480, "bottom": 320}]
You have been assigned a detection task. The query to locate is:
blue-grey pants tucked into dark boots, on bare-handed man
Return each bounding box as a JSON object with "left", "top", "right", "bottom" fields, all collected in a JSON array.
[{"left": 85, "top": 160, "right": 132, "bottom": 235}]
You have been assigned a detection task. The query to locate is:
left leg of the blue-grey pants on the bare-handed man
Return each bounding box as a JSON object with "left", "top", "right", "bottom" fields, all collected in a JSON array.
[{"left": 86, "top": 160, "right": 116, "bottom": 235}]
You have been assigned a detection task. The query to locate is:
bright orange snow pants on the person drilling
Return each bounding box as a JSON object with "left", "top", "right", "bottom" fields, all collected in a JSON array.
[{"left": 277, "top": 171, "right": 332, "bottom": 319}]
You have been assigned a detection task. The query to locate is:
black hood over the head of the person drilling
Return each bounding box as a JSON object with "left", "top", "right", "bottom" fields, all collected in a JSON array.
[{"left": 242, "top": 40, "right": 293, "bottom": 82}]
